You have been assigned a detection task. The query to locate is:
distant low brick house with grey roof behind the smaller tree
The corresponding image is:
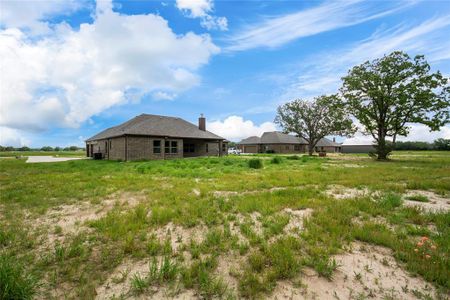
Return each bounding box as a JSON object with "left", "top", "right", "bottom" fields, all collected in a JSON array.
[{"left": 237, "top": 131, "right": 341, "bottom": 153}]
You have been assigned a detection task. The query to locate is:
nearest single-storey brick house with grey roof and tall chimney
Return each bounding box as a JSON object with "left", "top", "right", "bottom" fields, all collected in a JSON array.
[{"left": 86, "top": 114, "right": 227, "bottom": 161}]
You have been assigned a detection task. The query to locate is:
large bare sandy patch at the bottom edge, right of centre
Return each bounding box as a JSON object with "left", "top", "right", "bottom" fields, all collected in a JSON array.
[{"left": 271, "top": 242, "right": 436, "bottom": 299}]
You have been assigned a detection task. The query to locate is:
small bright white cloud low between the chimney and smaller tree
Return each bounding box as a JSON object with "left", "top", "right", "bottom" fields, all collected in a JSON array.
[{"left": 206, "top": 116, "right": 277, "bottom": 141}]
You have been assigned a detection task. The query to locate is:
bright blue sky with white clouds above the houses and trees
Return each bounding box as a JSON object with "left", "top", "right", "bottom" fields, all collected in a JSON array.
[{"left": 0, "top": 0, "right": 450, "bottom": 147}]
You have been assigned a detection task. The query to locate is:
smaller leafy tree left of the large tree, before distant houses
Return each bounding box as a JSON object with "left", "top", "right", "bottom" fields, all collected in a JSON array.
[{"left": 275, "top": 95, "right": 356, "bottom": 155}]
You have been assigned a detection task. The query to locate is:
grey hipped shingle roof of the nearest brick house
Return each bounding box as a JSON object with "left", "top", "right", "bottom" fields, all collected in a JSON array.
[{"left": 86, "top": 114, "right": 224, "bottom": 142}]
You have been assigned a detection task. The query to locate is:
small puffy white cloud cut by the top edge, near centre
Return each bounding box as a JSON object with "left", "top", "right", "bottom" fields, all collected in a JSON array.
[{"left": 176, "top": 0, "right": 228, "bottom": 31}]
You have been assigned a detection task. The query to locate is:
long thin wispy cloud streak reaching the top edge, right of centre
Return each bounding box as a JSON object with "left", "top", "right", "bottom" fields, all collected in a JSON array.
[{"left": 226, "top": 1, "right": 412, "bottom": 51}]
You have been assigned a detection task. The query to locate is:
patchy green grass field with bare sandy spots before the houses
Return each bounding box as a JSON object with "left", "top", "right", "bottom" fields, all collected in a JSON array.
[{"left": 0, "top": 151, "right": 450, "bottom": 299}]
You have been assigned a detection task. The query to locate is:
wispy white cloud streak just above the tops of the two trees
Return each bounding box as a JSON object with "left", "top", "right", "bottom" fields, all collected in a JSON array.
[{"left": 280, "top": 16, "right": 450, "bottom": 101}]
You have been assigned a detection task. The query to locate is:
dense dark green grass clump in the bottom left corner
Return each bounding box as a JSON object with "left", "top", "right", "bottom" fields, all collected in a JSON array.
[{"left": 0, "top": 255, "right": 36, "bottom": 299}]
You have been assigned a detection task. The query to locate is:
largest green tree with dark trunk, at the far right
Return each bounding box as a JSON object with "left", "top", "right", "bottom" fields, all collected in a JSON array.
[{"left": 341, "top": 51, "right": 450, "bottom": 159}]
